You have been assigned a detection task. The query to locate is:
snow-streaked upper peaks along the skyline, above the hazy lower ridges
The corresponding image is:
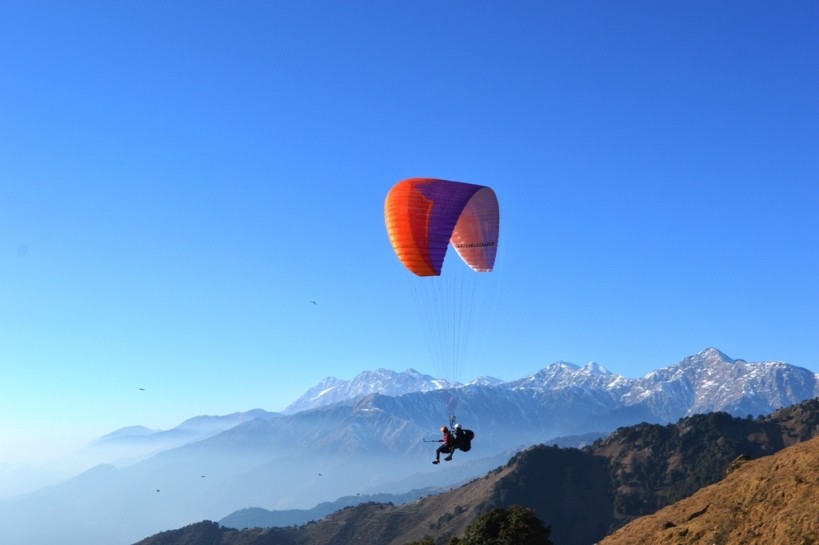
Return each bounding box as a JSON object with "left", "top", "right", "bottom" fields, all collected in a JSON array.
[{"left": 290, "top": 348, "right": 819, "bottom": 424}]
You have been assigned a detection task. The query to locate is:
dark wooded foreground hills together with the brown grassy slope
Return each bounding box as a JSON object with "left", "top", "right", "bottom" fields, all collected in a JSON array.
[{"left": 138, "top": 400, "right": 819, "bottom": 545}]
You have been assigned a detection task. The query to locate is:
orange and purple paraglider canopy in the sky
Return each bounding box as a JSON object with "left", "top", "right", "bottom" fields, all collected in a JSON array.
[{"left": 384, "top": 178, "right": 499, "bottom": 276}]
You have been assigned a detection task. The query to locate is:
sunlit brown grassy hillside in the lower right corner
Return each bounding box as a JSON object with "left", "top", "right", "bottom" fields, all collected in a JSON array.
[{"left": 599, "top": 438, "right": 819, "bottom": 545}]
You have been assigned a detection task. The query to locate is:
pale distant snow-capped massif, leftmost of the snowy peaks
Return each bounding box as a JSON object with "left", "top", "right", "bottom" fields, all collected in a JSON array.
[{"left": 282, "top": 369, "right": 460, "bottom": 414}]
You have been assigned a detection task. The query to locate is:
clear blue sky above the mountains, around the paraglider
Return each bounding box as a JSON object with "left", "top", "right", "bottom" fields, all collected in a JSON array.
[{"left": 0, "top": 0, "right": 819, "bottom": 464}]
